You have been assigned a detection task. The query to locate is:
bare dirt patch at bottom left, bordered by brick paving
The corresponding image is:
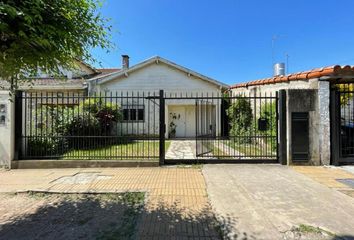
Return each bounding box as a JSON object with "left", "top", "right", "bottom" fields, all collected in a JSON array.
[{"left": 0, "top": 193, "right": 144, "bottom": 240}]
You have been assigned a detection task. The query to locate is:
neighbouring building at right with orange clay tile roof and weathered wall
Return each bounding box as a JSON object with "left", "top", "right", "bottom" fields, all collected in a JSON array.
[{"left": 231, "top": 65, "right": 354, "bottom": 165}]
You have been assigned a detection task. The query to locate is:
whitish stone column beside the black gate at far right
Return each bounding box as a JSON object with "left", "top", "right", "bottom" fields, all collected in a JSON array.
[{"left": 318, "top": 81, "right": 331, "bottom": 165}]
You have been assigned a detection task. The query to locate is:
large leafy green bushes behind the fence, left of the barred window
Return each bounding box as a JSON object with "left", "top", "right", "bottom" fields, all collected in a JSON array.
[{"left": 29, "top": 98, "right": 122, "bottom": 155}]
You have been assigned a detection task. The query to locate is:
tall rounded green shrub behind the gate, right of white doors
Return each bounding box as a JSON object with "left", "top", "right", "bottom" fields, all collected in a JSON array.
[{"left": 227, "top": 98, "right": 253, "bottom": 143}]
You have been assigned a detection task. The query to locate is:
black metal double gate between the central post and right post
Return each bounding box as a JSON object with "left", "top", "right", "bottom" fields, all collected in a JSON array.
[{"left": 164, "top": 92, "right": 280, "bottom": 164}]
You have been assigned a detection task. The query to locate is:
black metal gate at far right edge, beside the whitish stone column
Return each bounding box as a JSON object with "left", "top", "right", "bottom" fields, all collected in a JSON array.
[{"left": 331, "top": 83, "right": 354, "bottom": 165}]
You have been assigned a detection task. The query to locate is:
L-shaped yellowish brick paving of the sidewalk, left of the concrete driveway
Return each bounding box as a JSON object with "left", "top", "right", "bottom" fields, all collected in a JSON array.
[{"left": 0, "top": 167, "right": 219, "bottom": 239}]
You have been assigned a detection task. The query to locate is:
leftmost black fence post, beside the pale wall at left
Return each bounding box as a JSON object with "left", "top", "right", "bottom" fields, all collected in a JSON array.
[{"left": 14, "top": 91, "right": 23, "bottom": 160}]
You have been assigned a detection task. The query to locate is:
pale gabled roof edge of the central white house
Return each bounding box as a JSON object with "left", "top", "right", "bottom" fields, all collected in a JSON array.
[{"left": 88, "top": 56, "right": 229, "bottom": 88}]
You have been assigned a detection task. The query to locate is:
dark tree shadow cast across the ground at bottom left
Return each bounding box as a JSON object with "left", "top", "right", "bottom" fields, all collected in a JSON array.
[{"left": 0, "top": 193, "right": 249, "bottom": 240}]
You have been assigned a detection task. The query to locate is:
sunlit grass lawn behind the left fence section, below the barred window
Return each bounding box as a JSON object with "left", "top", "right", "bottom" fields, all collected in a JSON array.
[{"left": 62, "top": 140, "right": 170, "bottom": 161}]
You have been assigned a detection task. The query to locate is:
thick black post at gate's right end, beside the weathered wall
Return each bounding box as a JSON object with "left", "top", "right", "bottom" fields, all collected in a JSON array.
[{"left": 278, "top": 90, "right": 288, "bottom": 165}]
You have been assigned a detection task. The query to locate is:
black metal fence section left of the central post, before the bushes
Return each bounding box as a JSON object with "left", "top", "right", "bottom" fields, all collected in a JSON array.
[{"left": 17, "top": 92, "right": 160, "bottom": 160}]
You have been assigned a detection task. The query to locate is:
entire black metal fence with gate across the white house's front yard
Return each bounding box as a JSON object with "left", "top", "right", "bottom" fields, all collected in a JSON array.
[{"left": 16, "top": 90, "right": 279, "bottom": 164}]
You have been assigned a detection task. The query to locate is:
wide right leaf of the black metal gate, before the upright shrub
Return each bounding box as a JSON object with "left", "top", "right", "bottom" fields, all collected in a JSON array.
[{"left": 192, "top": 93, "right": 279, "bottom": 162}]
